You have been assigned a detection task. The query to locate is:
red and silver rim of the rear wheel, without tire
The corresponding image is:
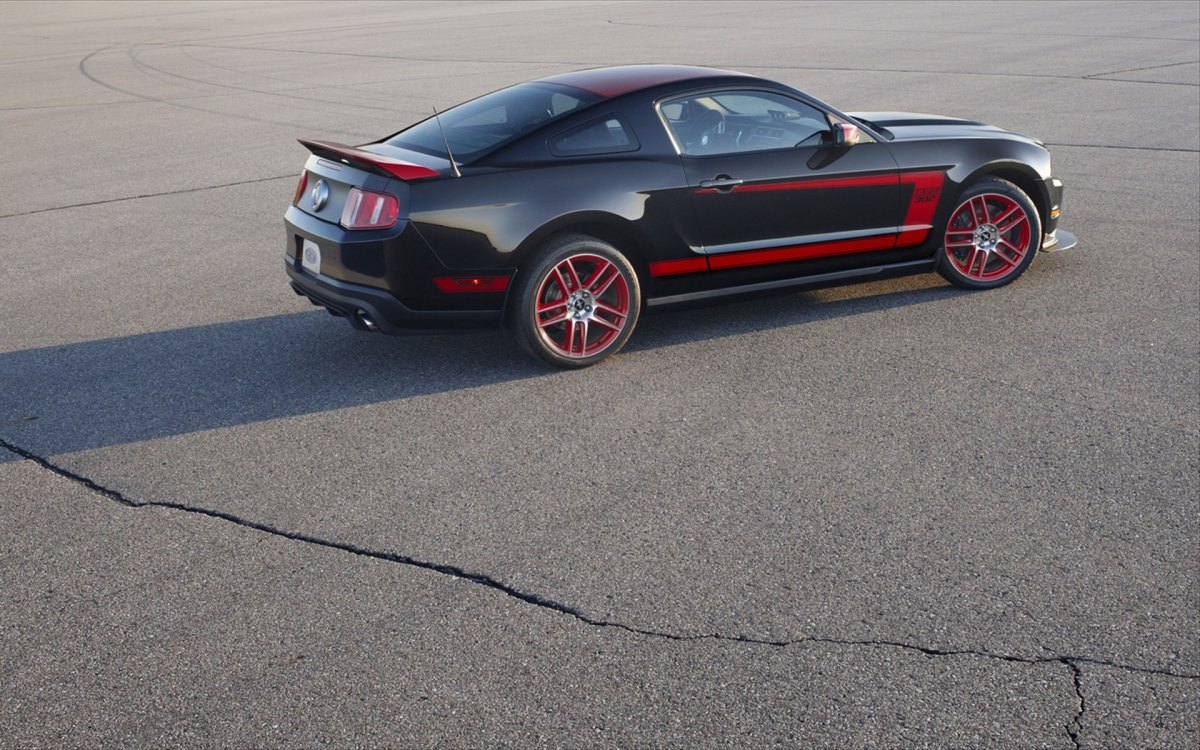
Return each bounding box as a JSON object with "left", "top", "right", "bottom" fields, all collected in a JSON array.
[{"left": 534, "top": 253, "right": 629, "bottom": 359}]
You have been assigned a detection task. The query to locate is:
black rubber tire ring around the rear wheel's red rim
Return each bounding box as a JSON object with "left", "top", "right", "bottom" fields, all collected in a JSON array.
[{"left": 508, "top": 234, "right": 642, "bottom": 368}]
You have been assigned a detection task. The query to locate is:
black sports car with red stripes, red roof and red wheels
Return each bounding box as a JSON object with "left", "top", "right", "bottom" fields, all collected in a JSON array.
[{"left": 286, "top": 65, "right": 1075, "bottom": 367}]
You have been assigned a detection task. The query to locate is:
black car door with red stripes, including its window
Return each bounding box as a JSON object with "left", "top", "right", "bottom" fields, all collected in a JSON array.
[{"left": 659, "top": 89, "right": 900, "bottom": 274}]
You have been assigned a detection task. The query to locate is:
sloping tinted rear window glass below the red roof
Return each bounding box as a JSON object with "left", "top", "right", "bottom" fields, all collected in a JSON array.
[{"left": 385, "top": 83, "right": 601, "bottom": 163}]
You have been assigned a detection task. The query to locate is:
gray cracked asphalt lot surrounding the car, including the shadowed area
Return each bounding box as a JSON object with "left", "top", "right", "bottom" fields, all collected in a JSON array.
[{"left": 0, "top": 2, "right": 1200, "bottom": 748}]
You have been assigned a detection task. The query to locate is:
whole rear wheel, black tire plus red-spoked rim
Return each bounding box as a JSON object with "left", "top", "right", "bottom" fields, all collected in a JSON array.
[{"left": 509, "top": 234, "right": 642, "bottom": 368}]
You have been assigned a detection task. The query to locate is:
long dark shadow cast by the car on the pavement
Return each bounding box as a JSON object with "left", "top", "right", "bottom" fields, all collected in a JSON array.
[{"left": 0, "top": 281, "right": 956, "bottom": 461}]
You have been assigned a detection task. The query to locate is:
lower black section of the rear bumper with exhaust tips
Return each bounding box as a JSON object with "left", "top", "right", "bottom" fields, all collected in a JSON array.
[{"left": 284, "top": 254, "right": 502, "bottom": 335}]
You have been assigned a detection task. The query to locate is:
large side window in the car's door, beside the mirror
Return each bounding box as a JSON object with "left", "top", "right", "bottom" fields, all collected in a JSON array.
[{"left": 659, "top": 91, "right": 833, "bottom": 156}]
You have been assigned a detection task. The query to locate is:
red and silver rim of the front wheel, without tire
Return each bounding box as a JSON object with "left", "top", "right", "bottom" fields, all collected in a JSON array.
[{"left": 946, "top": 193, "right": 1032, "bottom": 282}]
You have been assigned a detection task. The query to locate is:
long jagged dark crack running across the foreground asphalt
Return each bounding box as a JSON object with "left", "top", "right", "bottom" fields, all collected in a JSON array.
[{"left": 0, "top": 438, "right": 1200, "bottom": 750}]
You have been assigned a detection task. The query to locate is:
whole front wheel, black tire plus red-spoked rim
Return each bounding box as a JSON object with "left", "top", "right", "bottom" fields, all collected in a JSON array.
[{"left": 937, "top": 178, "right": 1042, "bottom": 289}]
